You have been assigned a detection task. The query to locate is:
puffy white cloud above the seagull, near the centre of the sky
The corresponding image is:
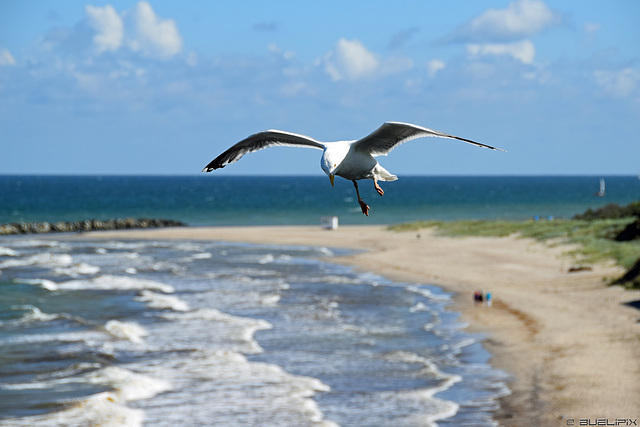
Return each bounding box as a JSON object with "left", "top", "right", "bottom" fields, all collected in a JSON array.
[{"left": 324, "top": 39, "right": 380, "bottom": 81}]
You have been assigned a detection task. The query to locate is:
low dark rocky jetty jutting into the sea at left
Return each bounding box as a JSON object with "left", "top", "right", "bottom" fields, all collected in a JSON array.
[{"left": 0, "top": 218, "right": 186, "bottom": 236}]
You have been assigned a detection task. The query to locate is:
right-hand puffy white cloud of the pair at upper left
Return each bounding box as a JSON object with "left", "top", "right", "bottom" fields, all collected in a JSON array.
[{"left": 127, "top": 2, "right": 182, "bottom": 59}]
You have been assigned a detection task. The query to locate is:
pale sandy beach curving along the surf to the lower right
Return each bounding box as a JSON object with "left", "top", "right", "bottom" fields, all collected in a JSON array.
[{"left": 85, "top": 226, "right": 640, "bottom": 426}]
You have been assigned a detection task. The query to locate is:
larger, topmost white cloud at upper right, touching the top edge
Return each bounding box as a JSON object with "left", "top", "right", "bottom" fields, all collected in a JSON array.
[{"left": 449, "top": 0, "right": 560, "bottom": 43}]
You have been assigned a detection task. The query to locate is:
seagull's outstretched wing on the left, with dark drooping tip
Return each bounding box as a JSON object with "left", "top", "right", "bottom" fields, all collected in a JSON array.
[{"left": 202, "top": 130, "right": 324, "bottom": 172}]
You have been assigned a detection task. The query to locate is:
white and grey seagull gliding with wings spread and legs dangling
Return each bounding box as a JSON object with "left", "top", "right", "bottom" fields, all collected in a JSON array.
[{"left": 202, "top": 122, "right": 504, "bottom": 216}]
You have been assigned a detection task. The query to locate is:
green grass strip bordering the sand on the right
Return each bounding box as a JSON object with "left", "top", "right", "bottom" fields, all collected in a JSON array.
[{"left": 389, "top": 218, "right": 640, "bottom": 269}]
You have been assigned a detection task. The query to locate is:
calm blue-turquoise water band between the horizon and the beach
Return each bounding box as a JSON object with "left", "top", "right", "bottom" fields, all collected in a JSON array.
[{"left": 0, "top": 174, "right": 640, "bottom": 225}]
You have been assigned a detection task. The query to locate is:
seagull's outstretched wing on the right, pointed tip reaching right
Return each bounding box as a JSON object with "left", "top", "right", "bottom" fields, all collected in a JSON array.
[{"left": 353, "top": 122, "right": 504, "bottom": 156}]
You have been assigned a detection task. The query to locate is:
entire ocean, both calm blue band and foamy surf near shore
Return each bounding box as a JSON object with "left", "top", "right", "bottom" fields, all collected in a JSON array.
[{"left": 0, "top": 176, "right": 640, "bottom": 426}]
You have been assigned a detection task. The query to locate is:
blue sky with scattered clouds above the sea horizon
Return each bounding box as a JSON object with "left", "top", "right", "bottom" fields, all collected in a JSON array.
[{"left": 0, "top": 0, "right": 640, "bottom": 177}]
